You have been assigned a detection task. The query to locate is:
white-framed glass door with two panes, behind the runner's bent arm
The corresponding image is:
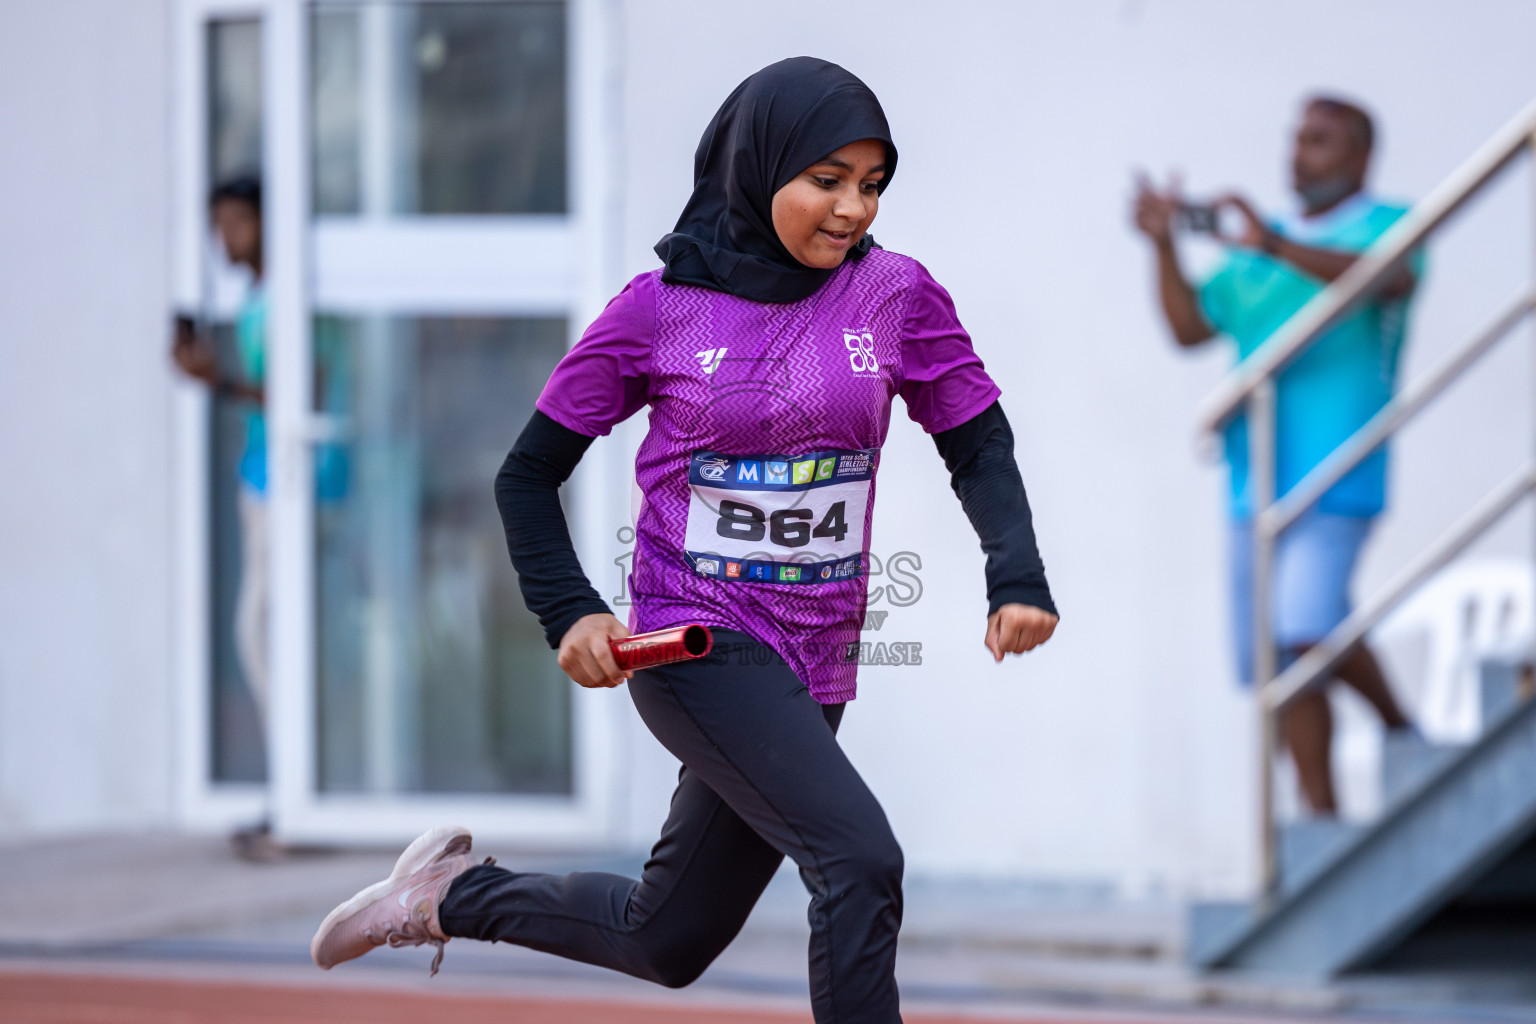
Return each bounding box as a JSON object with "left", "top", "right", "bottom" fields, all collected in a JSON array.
[{"left": 181, "top": 0, "right": 629, "bottom": 843}]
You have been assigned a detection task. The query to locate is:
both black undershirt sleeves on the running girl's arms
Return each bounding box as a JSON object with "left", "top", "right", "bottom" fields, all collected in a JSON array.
[{"left": 496, "top": 402, "right": 1055, "bottom": 648}]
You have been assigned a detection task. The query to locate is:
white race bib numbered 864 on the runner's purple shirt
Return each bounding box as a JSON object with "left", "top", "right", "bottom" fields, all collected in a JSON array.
[{"left": 684, "top": 448, "right": 880, "bottom": 583}]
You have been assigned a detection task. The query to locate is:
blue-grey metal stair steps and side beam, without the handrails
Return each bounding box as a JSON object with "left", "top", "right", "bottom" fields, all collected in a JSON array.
[{"left": 1189, "top": 662, "right": 1536, "bottom": 976}]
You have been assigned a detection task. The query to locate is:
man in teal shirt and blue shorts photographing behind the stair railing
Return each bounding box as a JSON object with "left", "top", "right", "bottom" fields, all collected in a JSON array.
[{"left": 1135, "top": 97, "right": 1421, "bottom": 815}]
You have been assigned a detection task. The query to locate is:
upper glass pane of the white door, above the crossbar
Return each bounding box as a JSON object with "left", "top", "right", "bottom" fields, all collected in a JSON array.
[{"left": 310, "top": 2, "right": 568, "bottom": 216}]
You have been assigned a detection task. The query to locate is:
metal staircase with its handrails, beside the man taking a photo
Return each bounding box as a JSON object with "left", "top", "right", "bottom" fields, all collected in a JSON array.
[{"left": 1187, "top": 95, "right": 1536, "bottom": 978}]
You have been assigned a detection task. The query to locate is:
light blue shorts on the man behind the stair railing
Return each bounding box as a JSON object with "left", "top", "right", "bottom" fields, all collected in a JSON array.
[{"left": 1229, "top": 510, "right": 1376, "bottom": 685}]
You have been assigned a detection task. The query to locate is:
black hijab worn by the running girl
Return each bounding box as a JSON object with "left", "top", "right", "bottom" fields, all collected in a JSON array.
[{"left": 656, "top": 57, "right": 895, "bottom": 302}]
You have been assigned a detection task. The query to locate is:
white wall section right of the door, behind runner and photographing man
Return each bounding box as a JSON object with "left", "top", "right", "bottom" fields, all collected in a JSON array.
[{"left": 610, "top": 0, "right": 1536, "bottom": 892}]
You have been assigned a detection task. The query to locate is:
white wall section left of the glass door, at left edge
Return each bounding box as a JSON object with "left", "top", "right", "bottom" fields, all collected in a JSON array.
[{"left": 0, "top": 0, "right": 172, "bottom": 841}]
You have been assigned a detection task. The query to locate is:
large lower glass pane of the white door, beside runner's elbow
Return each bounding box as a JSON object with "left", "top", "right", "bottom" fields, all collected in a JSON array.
[{"left": 313, "top": 316, "right": 573, "bottom": 794}]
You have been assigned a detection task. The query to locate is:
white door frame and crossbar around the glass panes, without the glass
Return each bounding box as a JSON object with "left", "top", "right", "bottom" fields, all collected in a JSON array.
[{"left": 174, "top": 0, "right": 628, "bottom": 846}]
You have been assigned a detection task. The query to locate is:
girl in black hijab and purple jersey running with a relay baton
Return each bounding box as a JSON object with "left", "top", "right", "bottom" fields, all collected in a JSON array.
[{"left": 312, "top": 57, "right": 1057, "bottom": 1022}]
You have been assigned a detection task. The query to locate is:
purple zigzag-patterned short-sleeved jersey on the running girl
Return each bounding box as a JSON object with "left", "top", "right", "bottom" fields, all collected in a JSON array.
[{"left": 538, "top": 249, "right": 998, "bottom": 703}]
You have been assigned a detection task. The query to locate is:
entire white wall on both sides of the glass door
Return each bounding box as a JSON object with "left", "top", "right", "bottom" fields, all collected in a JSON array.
[{"left": 0, "top": 0, "right": 1536, "bottom": 892}]
